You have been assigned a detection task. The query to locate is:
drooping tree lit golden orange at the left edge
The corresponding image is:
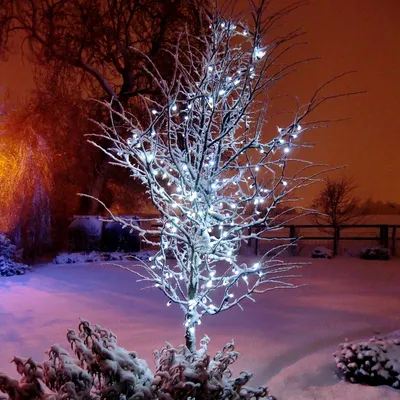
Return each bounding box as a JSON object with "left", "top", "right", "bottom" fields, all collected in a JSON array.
[{"left": 0, "top": 110, "right": 54, "bottom": 258}]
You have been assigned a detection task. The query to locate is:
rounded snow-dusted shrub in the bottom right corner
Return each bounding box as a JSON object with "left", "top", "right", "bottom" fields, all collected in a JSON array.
[{"left": 333, "top": 337, "right": 400, "bottom": 389}]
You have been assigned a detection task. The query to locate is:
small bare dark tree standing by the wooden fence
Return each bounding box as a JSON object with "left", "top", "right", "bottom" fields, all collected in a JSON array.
[{"left": 312, "top": 174, "right": 365, "bottom": 255}]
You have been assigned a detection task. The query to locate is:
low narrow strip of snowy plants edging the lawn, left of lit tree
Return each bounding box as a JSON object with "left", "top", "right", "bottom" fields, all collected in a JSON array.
[{"left": 53, "top": 251, "right": 154, "bottom": 264}]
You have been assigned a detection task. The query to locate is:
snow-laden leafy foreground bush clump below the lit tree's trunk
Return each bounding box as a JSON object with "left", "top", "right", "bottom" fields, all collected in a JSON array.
[{"left": 0, "top": 320, "right": 274, "bottom": 400}]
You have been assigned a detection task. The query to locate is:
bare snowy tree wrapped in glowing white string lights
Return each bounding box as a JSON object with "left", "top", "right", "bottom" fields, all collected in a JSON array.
[{"left": 85, "top": 1, "right": 354, "bottom": 352}]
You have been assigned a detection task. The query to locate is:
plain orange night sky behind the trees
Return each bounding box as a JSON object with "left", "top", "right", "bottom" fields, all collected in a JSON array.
[{"left": 0, "top": 0, "right": 400, "bottom": 203}]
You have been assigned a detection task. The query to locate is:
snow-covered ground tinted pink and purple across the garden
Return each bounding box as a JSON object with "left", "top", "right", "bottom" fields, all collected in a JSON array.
[{"left": 0, "top": 258, "right": 400, "bottom": 400}]
